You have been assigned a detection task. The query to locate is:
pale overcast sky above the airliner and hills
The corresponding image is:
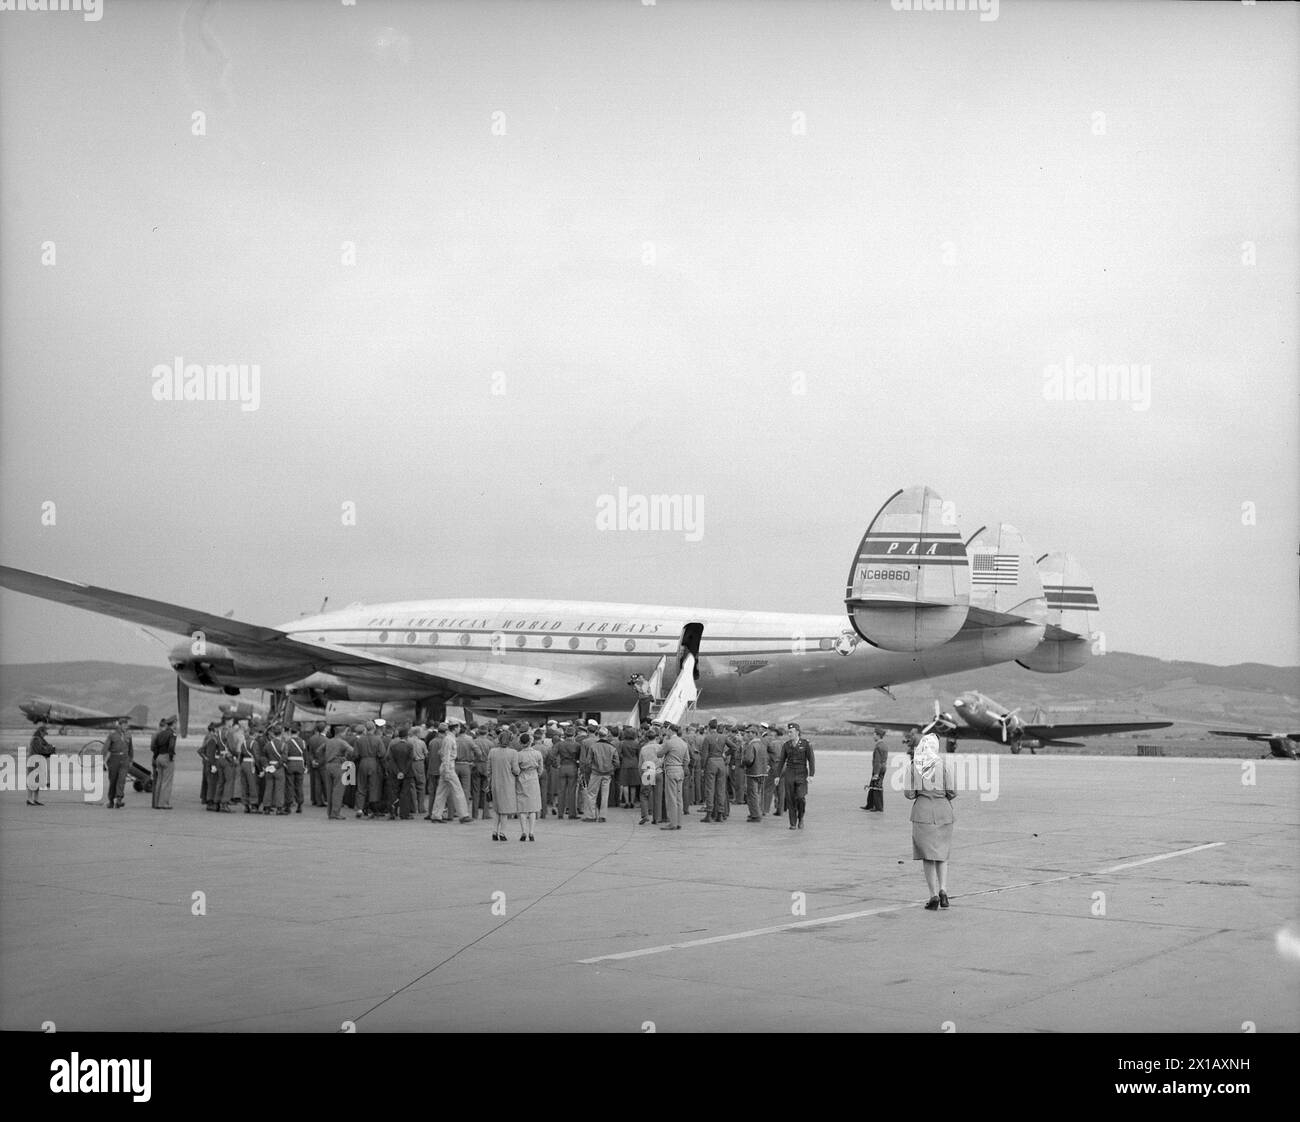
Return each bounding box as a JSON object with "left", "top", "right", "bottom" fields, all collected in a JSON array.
[{"left": 0, "top": 0, "right": 1300, "bottom": 664}]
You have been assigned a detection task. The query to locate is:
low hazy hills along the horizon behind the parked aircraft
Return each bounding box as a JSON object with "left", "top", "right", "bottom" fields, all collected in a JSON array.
[{"left": 0, "top": 651, "right": 1300, "bottom": 731}]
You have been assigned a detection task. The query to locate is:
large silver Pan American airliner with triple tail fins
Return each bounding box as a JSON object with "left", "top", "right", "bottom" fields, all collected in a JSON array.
[{"left": 0, "top": 486, "right": 1101, "bottom": 732}]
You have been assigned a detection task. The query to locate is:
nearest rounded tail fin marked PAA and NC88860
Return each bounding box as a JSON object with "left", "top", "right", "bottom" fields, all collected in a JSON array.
[{"left": 844, "top": 486, "right": 970, "bottom": 651}]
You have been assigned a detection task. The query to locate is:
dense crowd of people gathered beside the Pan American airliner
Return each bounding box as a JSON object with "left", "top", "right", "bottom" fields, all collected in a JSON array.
[{"left": 183, "top": 718, "right": 816, "bottom": 840}]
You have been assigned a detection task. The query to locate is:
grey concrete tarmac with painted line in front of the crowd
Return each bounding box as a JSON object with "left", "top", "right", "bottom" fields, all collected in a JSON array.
[{"left": 0, "top": 749, "right": 1300, "bottom": 1032}]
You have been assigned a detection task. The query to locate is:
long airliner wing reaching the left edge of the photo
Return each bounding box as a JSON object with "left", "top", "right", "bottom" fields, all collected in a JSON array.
[{"left": 0, "top": 566, "right": 594, "bottom": 702}]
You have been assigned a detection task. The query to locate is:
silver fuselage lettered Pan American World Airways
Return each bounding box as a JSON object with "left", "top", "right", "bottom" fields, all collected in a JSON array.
[{"left": 173, "top": 599, "right": 1043, "bottom": 711}]
